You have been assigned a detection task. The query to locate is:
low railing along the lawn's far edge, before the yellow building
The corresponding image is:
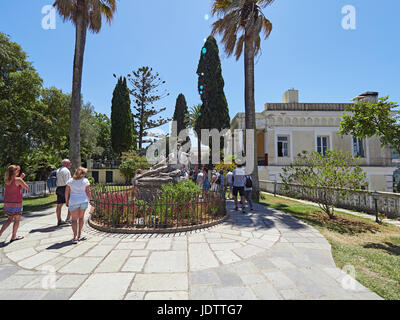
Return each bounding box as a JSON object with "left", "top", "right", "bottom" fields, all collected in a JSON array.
[{"left": 260, "top": 180, "right": 400, "bottom": 219}]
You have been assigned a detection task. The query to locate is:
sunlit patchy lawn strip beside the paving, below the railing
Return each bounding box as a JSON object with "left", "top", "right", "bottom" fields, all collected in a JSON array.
[{"left": 260, "top": 193, "right": 400, "bottom": 300}]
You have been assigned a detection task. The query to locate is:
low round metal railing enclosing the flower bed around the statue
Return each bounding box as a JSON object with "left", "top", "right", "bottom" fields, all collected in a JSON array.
[{"left": 91, "top": 186, "right": 226, "bottom": 230}]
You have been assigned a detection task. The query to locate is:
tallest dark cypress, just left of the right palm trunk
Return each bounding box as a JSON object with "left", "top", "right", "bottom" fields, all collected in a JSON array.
[{"left": 197, "top": 36, "right": 230, "bottom": 164}]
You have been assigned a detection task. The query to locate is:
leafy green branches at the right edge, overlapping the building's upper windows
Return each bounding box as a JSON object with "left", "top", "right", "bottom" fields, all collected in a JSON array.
[{"left": 339, "top": 97, "right": 400, "bottom": 153}]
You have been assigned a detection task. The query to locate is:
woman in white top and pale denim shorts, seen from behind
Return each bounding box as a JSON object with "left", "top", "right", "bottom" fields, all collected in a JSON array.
[{"left": 65, "top": 167, "right": 92, "bottom": 244}]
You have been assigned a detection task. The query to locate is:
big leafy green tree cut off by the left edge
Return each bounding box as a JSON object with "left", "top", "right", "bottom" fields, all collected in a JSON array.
[{"left": 0, "top": 33, "right": 45, "bottom": 166}]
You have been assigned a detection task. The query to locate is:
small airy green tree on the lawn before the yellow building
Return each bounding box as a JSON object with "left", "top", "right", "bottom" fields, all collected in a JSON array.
[{"left": 280, "top": 150, "right": 368, "bottom": 219}]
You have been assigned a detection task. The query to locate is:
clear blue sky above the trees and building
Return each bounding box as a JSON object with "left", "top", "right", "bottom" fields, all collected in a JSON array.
[{"left": 0, "top": 0, "right": 400, "bottom": 135}]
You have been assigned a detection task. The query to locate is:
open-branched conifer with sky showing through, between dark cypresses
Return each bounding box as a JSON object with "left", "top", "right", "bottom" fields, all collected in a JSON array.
[{"left": 128, "top": 67, "right": 171, "bottom": 150}]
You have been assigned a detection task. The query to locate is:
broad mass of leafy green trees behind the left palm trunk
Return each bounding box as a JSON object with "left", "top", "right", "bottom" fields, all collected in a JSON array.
[{"left": 0, "top": 33, "right": 112, "bottom": 180}]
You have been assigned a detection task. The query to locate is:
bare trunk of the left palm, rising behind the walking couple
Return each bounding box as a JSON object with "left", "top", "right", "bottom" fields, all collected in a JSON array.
[{"left": 69, "top": 0, "right": 87, "bottom": 171}]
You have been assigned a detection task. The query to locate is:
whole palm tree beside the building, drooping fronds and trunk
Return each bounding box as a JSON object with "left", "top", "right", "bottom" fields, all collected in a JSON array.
[{"left": 212, "top": 0, "right": 274, "bottom": 198}]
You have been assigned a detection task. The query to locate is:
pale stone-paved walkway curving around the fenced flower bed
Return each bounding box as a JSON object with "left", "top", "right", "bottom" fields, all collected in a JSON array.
[{"left": 0, "top": 203, "right": 381, "bottom": 300}]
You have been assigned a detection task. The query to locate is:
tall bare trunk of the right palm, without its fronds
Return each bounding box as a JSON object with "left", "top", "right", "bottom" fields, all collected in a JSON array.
[{"left": 244, "top": 32, "right": 260, "bottom": 200}]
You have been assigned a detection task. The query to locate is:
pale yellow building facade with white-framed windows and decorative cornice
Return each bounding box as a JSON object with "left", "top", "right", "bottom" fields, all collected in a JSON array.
[{"left": 231, "top": 89, "right": 396, "bottom": 192}]
